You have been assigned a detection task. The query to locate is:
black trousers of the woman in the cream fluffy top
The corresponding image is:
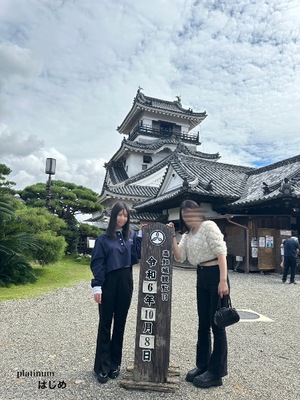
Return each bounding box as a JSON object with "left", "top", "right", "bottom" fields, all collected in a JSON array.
[{"left": 196, "top": 265, "right": 229, "bottom": 377}]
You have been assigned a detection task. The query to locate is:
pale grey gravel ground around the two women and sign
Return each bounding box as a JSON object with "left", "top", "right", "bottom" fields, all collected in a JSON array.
[{"left": 0, "top": 266, "right": 300, "bottom": 400}]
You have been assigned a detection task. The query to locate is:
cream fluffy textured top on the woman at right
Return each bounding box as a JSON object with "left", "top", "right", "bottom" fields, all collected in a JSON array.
[{"left": 177, "top": 221, "right": 227, "bottom": 266}]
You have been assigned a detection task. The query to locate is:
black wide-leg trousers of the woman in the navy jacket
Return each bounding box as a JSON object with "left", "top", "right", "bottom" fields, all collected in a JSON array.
[{"left": 94, "top": 267, "right": 133, "bottom": 374}]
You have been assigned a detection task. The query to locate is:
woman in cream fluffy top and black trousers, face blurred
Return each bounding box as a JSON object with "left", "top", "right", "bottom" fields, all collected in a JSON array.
[{"left": 168, "top": 200, "right": 229, "bottom": 388}]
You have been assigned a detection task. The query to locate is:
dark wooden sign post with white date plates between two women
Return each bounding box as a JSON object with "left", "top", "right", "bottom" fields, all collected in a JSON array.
[{"left": 121, "top": 222, "right": 179, "bottom": 392}]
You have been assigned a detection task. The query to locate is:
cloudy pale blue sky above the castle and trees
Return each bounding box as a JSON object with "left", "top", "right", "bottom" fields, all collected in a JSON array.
[{"left": 0, "top": 0, "right": 300, "bottom": 193}]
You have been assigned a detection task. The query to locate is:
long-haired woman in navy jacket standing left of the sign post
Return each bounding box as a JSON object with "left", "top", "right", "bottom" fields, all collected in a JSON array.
[{"left": 91, "top": 202, "right": 141, "bottom": 383}]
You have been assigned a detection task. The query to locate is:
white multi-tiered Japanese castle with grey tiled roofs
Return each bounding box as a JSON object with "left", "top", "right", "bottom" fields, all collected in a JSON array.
[{"left": 92, "top": 89, "right": 300, "bottom": 271}]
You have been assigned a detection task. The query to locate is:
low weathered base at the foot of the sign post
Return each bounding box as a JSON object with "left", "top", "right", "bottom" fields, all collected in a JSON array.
[{"left": 120, "top": 365, "right": 180, "bottom": 393}]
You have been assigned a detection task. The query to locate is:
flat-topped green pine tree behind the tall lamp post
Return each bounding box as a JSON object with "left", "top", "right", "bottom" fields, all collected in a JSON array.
[{"left": 19, "top": 180, "right": 102, "bottom": 253}]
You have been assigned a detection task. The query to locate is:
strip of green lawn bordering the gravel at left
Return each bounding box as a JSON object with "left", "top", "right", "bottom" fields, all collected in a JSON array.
[{"left": 0, "top": 256, "right": 92, "bottom": 301}]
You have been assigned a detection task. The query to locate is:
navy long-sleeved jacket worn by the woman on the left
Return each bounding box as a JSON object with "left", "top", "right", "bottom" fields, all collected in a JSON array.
[{"left": 91, "top": 230, "right": 142, "bottom": 287}]
